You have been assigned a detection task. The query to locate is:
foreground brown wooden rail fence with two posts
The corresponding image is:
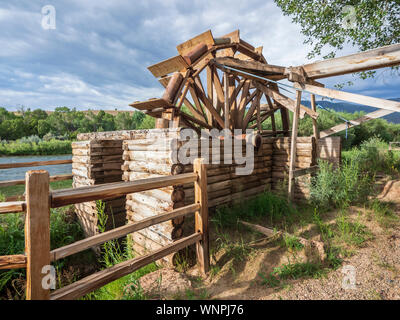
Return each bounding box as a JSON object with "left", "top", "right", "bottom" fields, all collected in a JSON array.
[{"left": 0, "top": 159, "right": 210, "bottom": 300}]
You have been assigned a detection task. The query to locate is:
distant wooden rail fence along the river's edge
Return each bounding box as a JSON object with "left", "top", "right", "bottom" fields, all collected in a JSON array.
[{"left": 0, "top": 160, "right": 72, "bottom": 188}]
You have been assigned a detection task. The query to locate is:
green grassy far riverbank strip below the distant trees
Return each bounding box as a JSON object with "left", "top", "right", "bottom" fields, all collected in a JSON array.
[{"left": 0, "top": 139, "right": 72, "bottom": 157}]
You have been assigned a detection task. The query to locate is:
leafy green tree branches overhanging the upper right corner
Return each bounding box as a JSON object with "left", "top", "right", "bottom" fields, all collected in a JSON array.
[{"left": 274, "top": 0, "right": 400, "bottom": 78}]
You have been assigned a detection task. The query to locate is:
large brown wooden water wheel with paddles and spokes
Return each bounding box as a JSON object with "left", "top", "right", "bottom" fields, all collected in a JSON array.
[{"left": 131, "top": 30, "right": 317, "bottom": 135}]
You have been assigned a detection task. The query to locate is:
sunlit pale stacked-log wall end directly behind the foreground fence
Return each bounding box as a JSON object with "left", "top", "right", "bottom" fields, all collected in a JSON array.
[{"left": 122, "top": 129, "right": 184, "bottom": 263}]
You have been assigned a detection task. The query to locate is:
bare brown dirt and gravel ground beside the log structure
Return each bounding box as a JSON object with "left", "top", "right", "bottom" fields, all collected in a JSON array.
[{"left": 156, "top": 181, "right": 400, "bottom": 300}]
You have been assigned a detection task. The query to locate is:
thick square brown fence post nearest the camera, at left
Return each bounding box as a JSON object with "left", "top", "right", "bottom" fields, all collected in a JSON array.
[{"left": 25, "top": 170, "right": 50, "bottom": 300}]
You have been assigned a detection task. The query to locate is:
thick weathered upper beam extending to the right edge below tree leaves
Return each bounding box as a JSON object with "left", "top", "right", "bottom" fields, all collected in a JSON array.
[{"left": 302, "top": 43, "right": 400, "bottom": 79}]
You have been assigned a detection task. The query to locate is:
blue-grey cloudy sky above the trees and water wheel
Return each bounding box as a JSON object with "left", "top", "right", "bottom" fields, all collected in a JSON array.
[{"left": 0, "top": 0, "right": 400, "bottom": 110}]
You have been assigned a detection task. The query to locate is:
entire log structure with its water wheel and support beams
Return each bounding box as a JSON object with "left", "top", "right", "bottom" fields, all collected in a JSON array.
[{"left": 73, "top": 30, "right": 400, "bottom": 262}]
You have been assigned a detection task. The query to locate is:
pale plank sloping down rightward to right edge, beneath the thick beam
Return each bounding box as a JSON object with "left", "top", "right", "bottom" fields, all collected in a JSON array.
[{"left": 294, "top": 83, "right": 400, "bottom": 112}]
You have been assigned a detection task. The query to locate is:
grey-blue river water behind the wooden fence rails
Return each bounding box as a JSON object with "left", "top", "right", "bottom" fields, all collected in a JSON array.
[{"left": 0, "top": 155, "right": 72, "bottom": 181}]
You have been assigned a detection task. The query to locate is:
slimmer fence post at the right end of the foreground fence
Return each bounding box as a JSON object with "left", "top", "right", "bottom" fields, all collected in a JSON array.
[{"left": 193, "top": 159, "right": 210, "bottom": 274}]
